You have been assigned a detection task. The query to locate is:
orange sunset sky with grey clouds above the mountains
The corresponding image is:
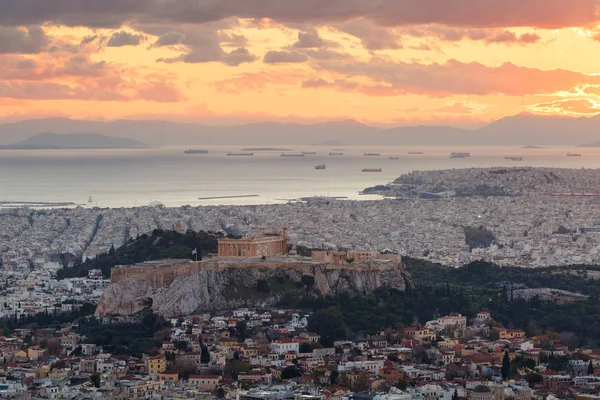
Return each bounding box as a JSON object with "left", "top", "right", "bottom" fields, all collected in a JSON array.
[{"left": 0, "top": 0, "right": 600, "bottom": 127}]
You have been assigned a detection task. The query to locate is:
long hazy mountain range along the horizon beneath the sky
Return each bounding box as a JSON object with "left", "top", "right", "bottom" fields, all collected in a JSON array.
[{"left": 0, "top": 114, "right": 600, "bottom": 147}]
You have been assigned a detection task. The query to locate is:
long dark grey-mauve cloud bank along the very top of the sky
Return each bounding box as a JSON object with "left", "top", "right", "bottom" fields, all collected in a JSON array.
[{"left": 0, "top": 0, "right": 598, "bottom": 29}]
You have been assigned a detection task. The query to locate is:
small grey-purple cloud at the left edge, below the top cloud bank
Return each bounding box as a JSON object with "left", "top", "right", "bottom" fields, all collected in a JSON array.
[{"left": 0, "top": 26, "right": 50, "bottom": 54}]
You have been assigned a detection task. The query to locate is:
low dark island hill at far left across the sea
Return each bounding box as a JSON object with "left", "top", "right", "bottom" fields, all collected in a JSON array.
[{"left": 3, "top": 133, "right": 148, "bottom": 149}]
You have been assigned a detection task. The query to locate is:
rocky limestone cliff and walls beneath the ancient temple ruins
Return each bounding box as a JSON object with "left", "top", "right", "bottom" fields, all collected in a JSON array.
[{"left": 96, "top": 260, "right": 411, "bottom": 317}]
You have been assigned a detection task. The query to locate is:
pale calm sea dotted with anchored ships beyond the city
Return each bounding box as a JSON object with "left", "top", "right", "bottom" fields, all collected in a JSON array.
[{"left": 0, "top": 145, "right": 600, "bottom": 208}]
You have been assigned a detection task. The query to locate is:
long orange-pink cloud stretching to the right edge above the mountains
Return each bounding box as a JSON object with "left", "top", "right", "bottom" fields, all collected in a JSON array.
[{"left": 312, "top": 58, "right": 600, "bottom": 97}]
